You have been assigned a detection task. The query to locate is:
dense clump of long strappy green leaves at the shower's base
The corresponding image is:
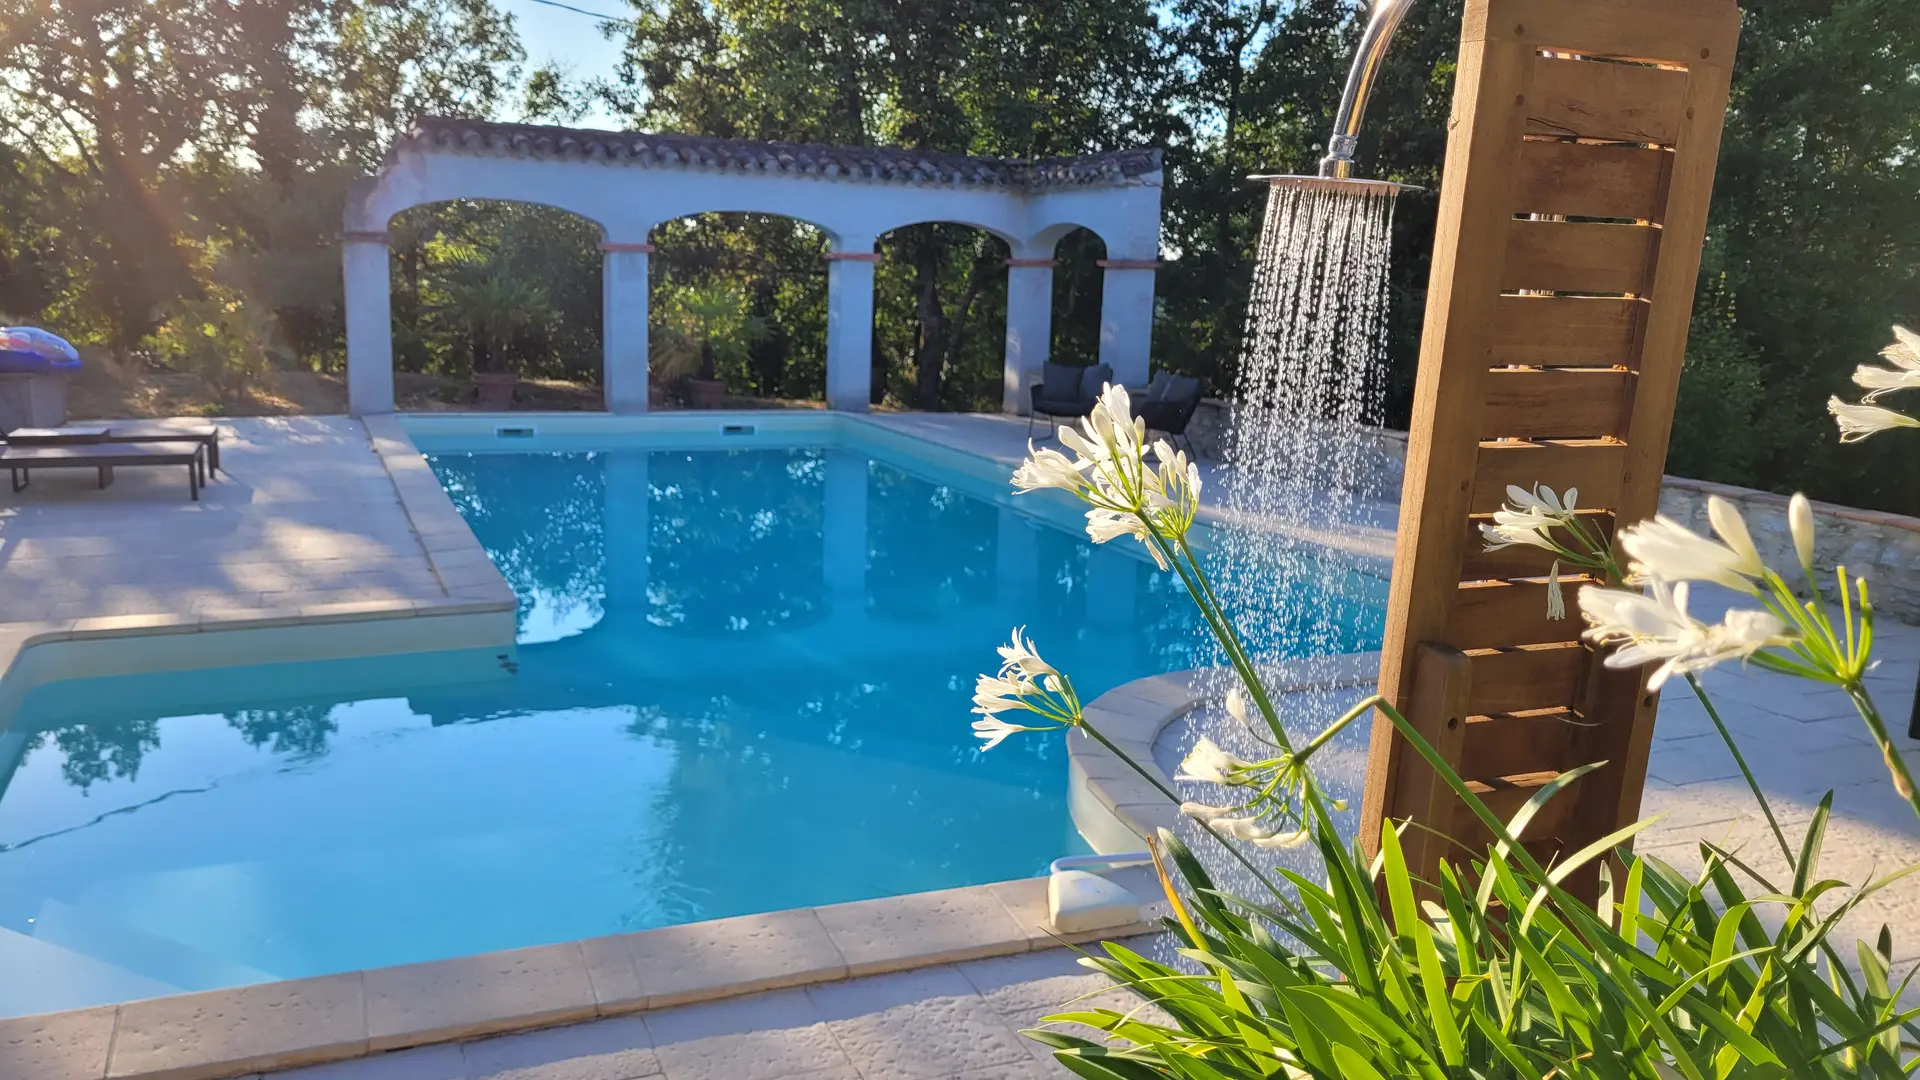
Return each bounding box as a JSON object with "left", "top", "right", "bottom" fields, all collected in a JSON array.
[{"left": 1052, "top": 791, "right": 1920, "bottom": 1080}]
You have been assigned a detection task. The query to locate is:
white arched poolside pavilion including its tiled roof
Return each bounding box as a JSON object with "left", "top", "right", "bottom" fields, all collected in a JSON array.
[{"left": 344, "top": 119, "right": 1160, "bottom": 415}]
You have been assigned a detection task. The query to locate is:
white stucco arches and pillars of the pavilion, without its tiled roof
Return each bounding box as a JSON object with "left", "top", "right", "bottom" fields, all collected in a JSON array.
[{"left": 344, "top": 133, "right": 1162, "bottom": 415}]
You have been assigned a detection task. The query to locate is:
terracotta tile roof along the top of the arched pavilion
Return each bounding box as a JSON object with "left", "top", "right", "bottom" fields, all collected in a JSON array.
[{"left": 394, "top": 117, "right": 1160, "bottom": 190}]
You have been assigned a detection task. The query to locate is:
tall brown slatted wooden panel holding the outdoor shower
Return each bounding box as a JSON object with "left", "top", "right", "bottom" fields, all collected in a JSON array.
[{"left": 1361, "top": 0, "right": 1740, "bottom": 888}]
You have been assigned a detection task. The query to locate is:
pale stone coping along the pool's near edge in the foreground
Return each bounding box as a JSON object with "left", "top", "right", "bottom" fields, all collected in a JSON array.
[{"left": 0, "top": 878, "right": 1160, "bottom": 1080}]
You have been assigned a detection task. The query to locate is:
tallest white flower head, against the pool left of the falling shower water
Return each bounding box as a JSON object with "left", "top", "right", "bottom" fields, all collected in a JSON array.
[{"left": 1014, "top": 384, "right": 1200, "bottom": 569}]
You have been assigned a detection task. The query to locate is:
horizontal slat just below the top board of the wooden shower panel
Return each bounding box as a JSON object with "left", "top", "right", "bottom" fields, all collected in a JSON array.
[{"left": 1526, "top": 56, "right": 1686, "bottom": 146}]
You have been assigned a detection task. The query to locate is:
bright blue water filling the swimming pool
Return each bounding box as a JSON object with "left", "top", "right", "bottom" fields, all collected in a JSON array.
[{"left": 0, "top": 428, "right": 1384, "bottom": 1015}]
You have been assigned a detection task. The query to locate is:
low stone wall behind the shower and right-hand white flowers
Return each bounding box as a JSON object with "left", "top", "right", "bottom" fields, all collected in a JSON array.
[{"left": 1187, "top": 398, "right": 1920, "bottom": 623}]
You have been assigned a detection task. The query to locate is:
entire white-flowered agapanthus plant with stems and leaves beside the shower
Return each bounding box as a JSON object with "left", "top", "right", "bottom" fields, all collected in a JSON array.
[{"left": 973, "top": 388, "right": 1920, "bottom": 1080}]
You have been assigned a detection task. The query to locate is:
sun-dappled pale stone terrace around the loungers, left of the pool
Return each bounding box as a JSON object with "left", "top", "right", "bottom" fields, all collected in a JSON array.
[{"left": 0, "top": 417, "right": 445, "bottom": 623}]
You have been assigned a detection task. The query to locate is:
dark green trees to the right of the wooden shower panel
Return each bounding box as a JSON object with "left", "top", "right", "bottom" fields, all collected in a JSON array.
[{"left": 1672, "top": 0, "right": 1920, "bottom": 513}]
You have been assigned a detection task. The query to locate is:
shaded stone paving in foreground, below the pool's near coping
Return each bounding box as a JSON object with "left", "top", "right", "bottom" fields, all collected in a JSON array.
[{"left": 275, "top": 940, "right": 1150, "bottom": 1080}]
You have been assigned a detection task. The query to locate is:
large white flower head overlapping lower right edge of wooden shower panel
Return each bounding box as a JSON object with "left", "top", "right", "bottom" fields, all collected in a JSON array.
[{"left": 1580, "top": 496, "right": 1812, "bottom": 690}]
